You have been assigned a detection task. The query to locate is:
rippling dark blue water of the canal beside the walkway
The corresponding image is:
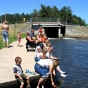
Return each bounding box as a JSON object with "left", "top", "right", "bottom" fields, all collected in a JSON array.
[{"left": 47, "top": 38, "right": 88, "bottom": 88}]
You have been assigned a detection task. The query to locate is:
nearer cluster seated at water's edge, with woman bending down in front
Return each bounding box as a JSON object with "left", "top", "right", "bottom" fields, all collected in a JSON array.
[{"left": 34, "top": 36, "right": 66, "bottom": 88}]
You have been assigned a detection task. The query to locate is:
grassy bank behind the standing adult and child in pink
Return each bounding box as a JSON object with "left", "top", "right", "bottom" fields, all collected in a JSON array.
[{"left": 0, "top": 24, "right": 29, "bottom": 49}]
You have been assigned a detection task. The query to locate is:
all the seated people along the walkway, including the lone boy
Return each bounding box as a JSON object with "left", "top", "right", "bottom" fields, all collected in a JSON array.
[{"left": 13, "top": 26, "right": 67, "bottom": 88}]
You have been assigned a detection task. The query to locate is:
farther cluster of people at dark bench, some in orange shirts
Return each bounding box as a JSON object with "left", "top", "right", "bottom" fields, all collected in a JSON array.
[{"left": 26, "top": 28, "right": 47, "bottom": 52}]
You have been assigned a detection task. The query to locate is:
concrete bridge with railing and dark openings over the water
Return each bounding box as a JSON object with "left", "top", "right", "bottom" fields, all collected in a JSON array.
[{"left": 31, "top": 18, "right": 66, "bottom": 38}]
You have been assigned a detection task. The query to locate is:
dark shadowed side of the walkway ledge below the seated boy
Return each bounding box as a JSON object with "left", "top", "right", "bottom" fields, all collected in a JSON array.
[{"left": 0, "top": 75, "right": 51, "bottom": 88}]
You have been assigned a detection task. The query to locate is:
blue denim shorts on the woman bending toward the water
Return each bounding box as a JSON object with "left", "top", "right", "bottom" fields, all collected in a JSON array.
[{"left": 34, "top": 63, "right": 50, "bottom": 78}]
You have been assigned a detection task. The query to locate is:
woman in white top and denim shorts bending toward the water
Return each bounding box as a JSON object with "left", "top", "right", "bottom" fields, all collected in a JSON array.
[{"left": 34, "top": 55, "right": 57, "bottom": 88}]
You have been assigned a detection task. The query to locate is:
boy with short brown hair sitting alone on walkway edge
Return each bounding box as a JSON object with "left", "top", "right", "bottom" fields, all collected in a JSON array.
[{"left": 13, "top": 57, "right": 31, "bottom": 88}]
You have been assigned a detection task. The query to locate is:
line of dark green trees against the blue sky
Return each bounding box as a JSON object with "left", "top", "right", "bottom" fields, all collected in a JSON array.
[{"left": 0, "top": 4, "right": 87, "bottom": 26}]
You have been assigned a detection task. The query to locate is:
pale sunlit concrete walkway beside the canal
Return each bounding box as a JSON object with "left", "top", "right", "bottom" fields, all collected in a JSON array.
[{"left": 0, "top": 38, "right": 35, "bottom": 83}]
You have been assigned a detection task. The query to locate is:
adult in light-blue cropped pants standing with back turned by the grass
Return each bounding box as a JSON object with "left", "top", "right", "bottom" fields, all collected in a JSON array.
[{"left": 1, "top": 21, "right": 9, "bottom": 48}]
